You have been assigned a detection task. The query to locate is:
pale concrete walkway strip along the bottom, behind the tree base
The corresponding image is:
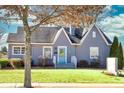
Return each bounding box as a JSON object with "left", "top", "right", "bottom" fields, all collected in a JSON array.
[{"left": 0, "top": 83, "right": 124, "bottom": 88}]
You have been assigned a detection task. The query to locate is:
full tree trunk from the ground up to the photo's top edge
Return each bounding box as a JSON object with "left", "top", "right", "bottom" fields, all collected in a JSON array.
[{"left": 20, "top": 6, "right": 32, "bottom": 88}]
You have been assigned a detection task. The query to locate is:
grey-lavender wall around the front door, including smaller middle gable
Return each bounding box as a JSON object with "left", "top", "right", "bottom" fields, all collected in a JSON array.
[{"left": 32, "top": 31, "right": 75, "bottom": 65}]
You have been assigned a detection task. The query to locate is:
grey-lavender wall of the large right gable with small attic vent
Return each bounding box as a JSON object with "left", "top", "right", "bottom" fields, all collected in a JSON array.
[{"left": 76, "top": 26, "right": 110, "bottom": 66}]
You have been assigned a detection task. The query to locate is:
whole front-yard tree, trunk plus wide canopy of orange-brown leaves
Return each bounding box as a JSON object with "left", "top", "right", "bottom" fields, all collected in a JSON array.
[{"left": 0, "top": 5, "right": 105, "bottom": 87}]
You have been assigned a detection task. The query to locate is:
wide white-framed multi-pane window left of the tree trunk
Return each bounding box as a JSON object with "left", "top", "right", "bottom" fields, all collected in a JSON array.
[{"left": 13, "top": 46, "right": 25, "bottom": 55}]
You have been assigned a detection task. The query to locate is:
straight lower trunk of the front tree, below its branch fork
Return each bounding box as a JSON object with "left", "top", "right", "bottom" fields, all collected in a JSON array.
[{"left": 24, "top": 26, "right": 31, "bottom": 88}]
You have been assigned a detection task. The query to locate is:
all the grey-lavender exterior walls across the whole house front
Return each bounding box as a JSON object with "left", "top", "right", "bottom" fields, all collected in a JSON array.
[{"left": 8, "top": 26, "right": 110, "bottom": 66}]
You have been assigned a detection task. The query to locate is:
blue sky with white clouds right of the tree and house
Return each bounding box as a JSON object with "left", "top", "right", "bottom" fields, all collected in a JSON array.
[{"left": 98, "top": 5, "right": 124, "bottom": 45}]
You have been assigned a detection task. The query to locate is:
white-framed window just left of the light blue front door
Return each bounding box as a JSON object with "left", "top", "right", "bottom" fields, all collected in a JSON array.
[{"left": 43, "top": 46, "right": 52, "bottom": 58}]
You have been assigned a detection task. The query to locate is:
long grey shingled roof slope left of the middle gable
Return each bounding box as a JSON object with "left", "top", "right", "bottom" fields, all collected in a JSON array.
[{"left": 7, "top": 27, "right": 60, "bottom": 43}]
